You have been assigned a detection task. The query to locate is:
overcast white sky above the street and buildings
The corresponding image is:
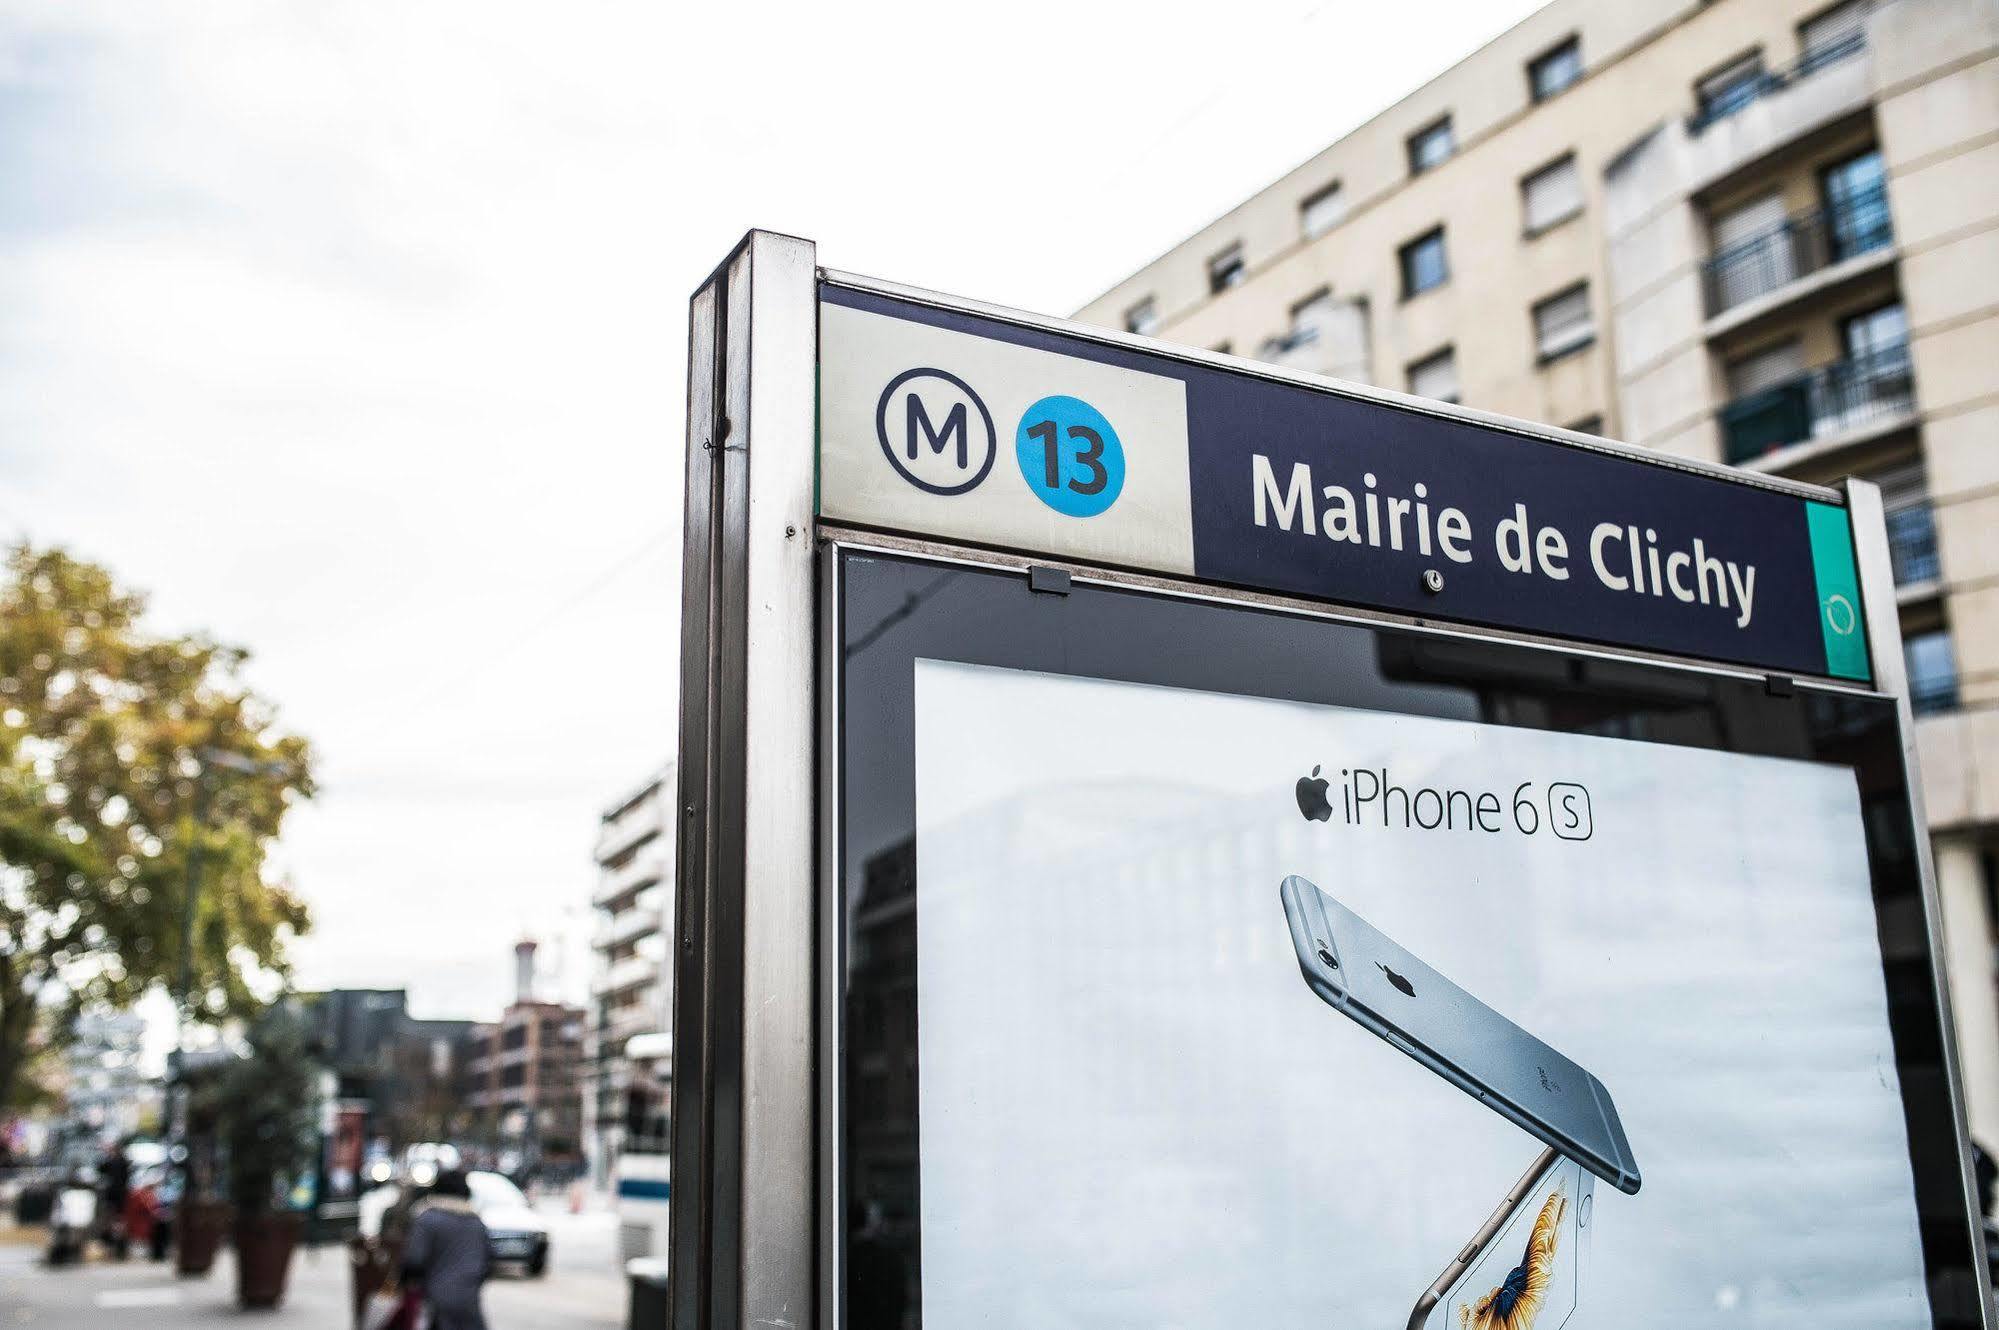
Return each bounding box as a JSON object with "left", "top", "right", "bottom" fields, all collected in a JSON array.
[{"left": 0, "top": 0, "right": 1537, "bottom": 1016}]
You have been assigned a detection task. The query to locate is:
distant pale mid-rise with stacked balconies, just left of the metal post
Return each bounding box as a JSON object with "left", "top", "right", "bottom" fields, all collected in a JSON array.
[{"left": 584, "top": 766, "right": 678, "bottom": 1184}]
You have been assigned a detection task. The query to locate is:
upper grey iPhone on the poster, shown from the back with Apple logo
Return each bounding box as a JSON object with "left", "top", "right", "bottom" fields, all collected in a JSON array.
[{"left": 1281, "top": 876, "right": 1639, "bottom": 1192}]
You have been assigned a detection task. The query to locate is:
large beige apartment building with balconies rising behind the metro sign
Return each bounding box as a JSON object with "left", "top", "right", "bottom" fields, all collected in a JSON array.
[{"left": 1079, "top": 0, "right": 1999, "bottom": 1146}]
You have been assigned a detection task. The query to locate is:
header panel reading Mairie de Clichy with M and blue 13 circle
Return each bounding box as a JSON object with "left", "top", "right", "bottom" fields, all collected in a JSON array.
[{"left": 820, "top": 284, "right": 1869, "bottom": 680}]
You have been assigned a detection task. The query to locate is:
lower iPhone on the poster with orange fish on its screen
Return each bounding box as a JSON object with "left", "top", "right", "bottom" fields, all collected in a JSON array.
[{"left": 1409, "top": 1150, "right": 1595, "bottom": 1330}]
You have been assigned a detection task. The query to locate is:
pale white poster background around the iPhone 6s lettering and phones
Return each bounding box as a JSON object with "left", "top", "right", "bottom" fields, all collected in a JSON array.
[{"left": 916, "top": 662, "right": 1929, "bottom": 1330}]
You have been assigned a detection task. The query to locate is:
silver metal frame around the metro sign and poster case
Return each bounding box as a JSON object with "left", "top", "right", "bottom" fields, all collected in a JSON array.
[{"left": 670, "top": 232, "right": 1991, "bottom": 1330}]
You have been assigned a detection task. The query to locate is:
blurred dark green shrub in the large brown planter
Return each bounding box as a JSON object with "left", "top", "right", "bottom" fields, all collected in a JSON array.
[{"left": 190, "top": 1006, "right": 320, "bottom": 1214}]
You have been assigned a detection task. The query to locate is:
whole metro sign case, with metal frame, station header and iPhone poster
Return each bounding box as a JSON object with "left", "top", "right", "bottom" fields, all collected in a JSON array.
[{"left": 672, "top": 232, "right": 1989, "bottom": 1330}]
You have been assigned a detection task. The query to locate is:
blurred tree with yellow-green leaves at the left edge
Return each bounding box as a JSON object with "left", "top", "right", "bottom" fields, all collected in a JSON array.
[{"left": 0, "top": 546, "right": 312, "bottom": 1104}]
